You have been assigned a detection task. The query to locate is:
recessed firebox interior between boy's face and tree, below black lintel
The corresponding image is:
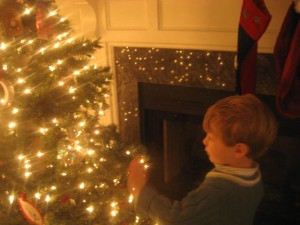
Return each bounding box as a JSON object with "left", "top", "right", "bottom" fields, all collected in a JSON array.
[{"left": 144, "top": 110, "right": 212, "bottom": 199}]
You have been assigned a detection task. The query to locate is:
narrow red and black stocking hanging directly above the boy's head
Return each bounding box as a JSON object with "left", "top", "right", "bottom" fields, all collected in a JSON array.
[{"left": 236, "top": 0, "right": 271, "bottom": 94}]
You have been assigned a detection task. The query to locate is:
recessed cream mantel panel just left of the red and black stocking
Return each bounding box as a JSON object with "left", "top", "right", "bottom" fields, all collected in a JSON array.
[{"left": 158, "top": 0, "right": 241, "bottom": 32}]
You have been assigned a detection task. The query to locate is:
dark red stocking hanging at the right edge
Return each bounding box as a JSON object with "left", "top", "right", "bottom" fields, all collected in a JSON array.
[{"left": 274, "top": 3, "right": 300, "bottom": 118}]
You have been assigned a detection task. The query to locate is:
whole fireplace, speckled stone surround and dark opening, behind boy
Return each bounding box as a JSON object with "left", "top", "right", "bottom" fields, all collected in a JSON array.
[{"left": 114, "top": 47, "right": 300, "bottom": 225}]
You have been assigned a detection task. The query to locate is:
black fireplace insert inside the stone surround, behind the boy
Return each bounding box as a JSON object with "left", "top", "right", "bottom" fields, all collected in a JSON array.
[{"left": 138, "top": 83, "right": 300, "bottom": 225}]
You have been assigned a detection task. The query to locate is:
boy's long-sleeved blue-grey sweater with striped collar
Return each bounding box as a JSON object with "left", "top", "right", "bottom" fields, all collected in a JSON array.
[{"left": 136, "top": 165, "right": 263, "bottom": 225}]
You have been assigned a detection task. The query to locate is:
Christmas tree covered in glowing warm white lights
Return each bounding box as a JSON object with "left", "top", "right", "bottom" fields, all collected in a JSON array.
[{"left": 0, "top": 0, "right": 148, "bottom": 225}]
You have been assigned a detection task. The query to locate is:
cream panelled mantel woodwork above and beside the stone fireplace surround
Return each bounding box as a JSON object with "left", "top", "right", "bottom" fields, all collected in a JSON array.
[{"left": 56, "top": 0, "right": 292, "bottom": 124}]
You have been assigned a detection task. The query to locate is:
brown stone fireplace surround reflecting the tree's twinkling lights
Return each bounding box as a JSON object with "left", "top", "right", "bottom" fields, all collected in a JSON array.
[{"left": 114, "top": 46, "right": 276, "bottom": 141}]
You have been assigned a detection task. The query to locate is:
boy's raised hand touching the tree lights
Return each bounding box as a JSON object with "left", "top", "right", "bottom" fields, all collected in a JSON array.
[{"left": 127, "top": 157, "right": 148, "bottom": 199}]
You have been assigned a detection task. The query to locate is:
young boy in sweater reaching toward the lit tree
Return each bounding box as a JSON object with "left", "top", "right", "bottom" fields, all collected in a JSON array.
[{"left": 128, "top": 94, "right": 277, "bottom": 225}]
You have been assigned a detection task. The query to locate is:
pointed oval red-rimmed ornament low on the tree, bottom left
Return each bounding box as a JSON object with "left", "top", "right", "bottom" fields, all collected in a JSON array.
[{"left": 18, "top": 193, "right": 44, "bottom": 225}]
